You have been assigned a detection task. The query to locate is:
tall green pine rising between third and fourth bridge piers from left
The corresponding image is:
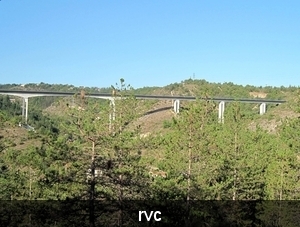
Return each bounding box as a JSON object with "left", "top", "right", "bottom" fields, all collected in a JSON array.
[{"left": 159, "top": 101, "right": 217, "bottom": 201}]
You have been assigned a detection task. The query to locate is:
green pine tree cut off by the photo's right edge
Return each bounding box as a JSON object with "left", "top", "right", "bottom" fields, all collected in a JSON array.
[{"left": 266, "top": 118, "right": 300, "bottom": 200}]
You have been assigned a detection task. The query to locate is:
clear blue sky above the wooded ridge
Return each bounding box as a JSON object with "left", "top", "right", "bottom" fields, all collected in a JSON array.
[{"left": 0, "top": 0, "right": 300, "bottom": 88}]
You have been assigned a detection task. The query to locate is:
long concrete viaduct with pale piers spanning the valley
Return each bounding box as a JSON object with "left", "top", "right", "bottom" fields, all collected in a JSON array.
[{"left": 0, "top": 90, "right": 286, "bottom": 124}]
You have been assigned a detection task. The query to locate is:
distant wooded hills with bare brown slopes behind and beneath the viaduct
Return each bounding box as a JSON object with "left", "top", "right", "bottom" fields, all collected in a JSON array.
[{"left": 0, "top": 79, "right": 299, "bottom": 163}]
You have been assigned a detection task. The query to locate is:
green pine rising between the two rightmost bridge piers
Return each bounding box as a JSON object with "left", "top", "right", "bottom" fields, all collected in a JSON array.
[{"left": 218, "top": 103, "right": 265, "bottom": 200}]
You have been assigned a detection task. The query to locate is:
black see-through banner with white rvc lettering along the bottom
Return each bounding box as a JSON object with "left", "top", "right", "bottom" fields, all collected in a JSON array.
[{"left": 0, "top": 200, "right": 300, "bottom": 227}]
